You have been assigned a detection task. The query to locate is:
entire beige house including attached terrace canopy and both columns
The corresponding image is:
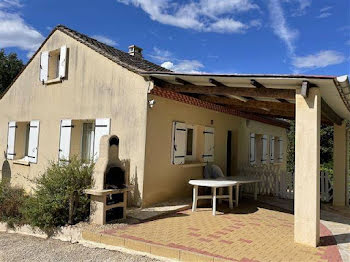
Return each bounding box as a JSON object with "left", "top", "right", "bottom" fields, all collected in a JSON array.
[{"left": 0, "top": 26, "right": 350, "bottom": 246}]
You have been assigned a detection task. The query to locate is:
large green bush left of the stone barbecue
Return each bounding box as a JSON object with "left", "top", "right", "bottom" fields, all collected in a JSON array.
[{"left": 23, "top": 157, "right": 94, "bottom": 234}]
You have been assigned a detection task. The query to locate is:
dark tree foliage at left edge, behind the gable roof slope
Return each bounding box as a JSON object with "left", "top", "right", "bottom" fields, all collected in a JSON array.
[{"left": 0, "top": 49, "right": 24, "bottom": 94}]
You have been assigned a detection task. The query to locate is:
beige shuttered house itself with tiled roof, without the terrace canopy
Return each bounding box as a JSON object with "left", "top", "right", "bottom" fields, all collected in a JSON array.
[{"left": 0, "top": 26, "right": 288, "bottom": 206}]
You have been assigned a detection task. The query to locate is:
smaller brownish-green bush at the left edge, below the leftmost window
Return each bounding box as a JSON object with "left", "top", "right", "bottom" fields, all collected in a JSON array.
[{"left": 0, "top": 180, "right": 25, "bottom": 227}]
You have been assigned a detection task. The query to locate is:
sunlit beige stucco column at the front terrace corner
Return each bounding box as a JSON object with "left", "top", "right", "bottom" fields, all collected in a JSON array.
[{"left": 294, "top": 88, "right": 321, "bottom": 247}]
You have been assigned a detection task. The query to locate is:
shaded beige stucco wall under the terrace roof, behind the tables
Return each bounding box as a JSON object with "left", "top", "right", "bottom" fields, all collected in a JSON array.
[{"left": 143, "top": 95, "right": 287, "bottom": 206}]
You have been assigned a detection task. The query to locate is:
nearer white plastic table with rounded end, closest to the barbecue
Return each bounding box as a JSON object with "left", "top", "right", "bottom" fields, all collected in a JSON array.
[{"left": 189, "top": 179, "right": 237, "bottom": 216}]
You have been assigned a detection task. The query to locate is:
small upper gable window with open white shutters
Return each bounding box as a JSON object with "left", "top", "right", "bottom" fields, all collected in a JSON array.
[{"left": 40, "top": 46, "right": 67, "bottom": 84}]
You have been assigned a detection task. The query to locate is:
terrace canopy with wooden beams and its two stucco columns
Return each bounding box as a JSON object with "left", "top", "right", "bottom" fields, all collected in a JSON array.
[{"left": 143, "top": 72, "right": 350, "bottom": 247}]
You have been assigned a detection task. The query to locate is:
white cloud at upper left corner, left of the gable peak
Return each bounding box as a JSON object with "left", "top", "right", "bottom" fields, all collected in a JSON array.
[{"left": 0, "top": 0, "right": 44, "bottom": 55}]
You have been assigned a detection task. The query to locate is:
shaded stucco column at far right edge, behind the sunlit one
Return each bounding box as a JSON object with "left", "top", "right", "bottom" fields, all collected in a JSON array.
[{"left": 333, "top": 121, "right": 347, "bottom": 206}]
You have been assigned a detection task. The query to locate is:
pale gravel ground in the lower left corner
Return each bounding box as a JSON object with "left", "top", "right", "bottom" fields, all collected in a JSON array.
[{"left": 0, "top": 233, "right": 159, "bottom": 262}]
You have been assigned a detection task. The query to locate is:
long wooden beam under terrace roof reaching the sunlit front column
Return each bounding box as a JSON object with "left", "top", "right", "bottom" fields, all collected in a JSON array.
[{"left": 153, "top": 78, "right": 295, "bottom": 100}]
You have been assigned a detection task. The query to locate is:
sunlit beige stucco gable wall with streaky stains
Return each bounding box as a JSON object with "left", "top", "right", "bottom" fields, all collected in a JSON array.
[{"left": 0, "top": 31, "right": 148, "bottom": 206}]
